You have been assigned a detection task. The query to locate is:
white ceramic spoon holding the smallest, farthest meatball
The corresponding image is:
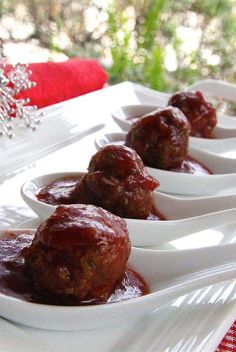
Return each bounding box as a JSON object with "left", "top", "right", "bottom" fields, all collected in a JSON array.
[{"left": 111, "top": 105, "right": 236, "bottom": 143}]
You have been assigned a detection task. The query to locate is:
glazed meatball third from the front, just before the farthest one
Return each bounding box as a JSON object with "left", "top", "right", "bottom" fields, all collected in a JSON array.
[{"left": 125, "top": 106, "right": 190, "bottom": 170}]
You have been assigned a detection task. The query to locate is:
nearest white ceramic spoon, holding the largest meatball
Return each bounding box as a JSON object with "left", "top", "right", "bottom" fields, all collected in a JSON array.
[{"left": 0, "top": 230, "right": 236, "bottom": 331}]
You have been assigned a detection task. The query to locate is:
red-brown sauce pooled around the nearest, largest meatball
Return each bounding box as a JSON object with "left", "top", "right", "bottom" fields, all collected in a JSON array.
[{"left": 0, "top": 230, "right": 149, "bottom": 305}]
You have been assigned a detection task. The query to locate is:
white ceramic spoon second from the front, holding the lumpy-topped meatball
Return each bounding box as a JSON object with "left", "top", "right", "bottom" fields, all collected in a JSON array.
[{"left": 21, "top": 172, "right": 236, "bottom": 247}]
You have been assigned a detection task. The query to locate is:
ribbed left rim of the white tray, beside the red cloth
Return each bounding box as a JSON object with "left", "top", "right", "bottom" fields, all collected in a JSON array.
[{"left": 0, "top": 82, "right": 162, "bottom": 182}]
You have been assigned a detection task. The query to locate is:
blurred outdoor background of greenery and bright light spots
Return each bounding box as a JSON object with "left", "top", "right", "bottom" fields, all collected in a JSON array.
[{"left": 0, "top": 0, "right": 236, "bottom": 92}]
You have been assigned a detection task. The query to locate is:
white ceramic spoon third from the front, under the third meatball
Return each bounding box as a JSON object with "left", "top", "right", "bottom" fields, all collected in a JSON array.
[{"left": 95, "top": 132, "right": 236, "bottom": 195}]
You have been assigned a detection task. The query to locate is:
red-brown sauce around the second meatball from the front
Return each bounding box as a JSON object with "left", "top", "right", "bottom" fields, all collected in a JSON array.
[{"left": 36, "top": 176, "right": 166, "bottom": 220}]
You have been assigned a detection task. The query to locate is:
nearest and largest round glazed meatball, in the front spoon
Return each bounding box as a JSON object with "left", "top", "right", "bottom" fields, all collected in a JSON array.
[{"left": 26, "top": 204, "right": 131, "bottom": 305}]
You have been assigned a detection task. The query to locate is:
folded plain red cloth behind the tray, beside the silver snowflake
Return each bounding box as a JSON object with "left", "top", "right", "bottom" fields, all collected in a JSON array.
[{"left": 11, "top": 59, "right": 107, "bottom": 108}]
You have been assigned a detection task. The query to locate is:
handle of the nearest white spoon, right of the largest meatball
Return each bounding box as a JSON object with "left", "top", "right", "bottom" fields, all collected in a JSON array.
[{"left": 131, "top": 243, "right": 236, "bottom": 289}]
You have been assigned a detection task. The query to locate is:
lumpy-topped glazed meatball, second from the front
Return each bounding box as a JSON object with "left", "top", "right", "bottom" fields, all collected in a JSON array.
[{"left": 72, "top": 145, "right": 159, "bottom": 219}]
